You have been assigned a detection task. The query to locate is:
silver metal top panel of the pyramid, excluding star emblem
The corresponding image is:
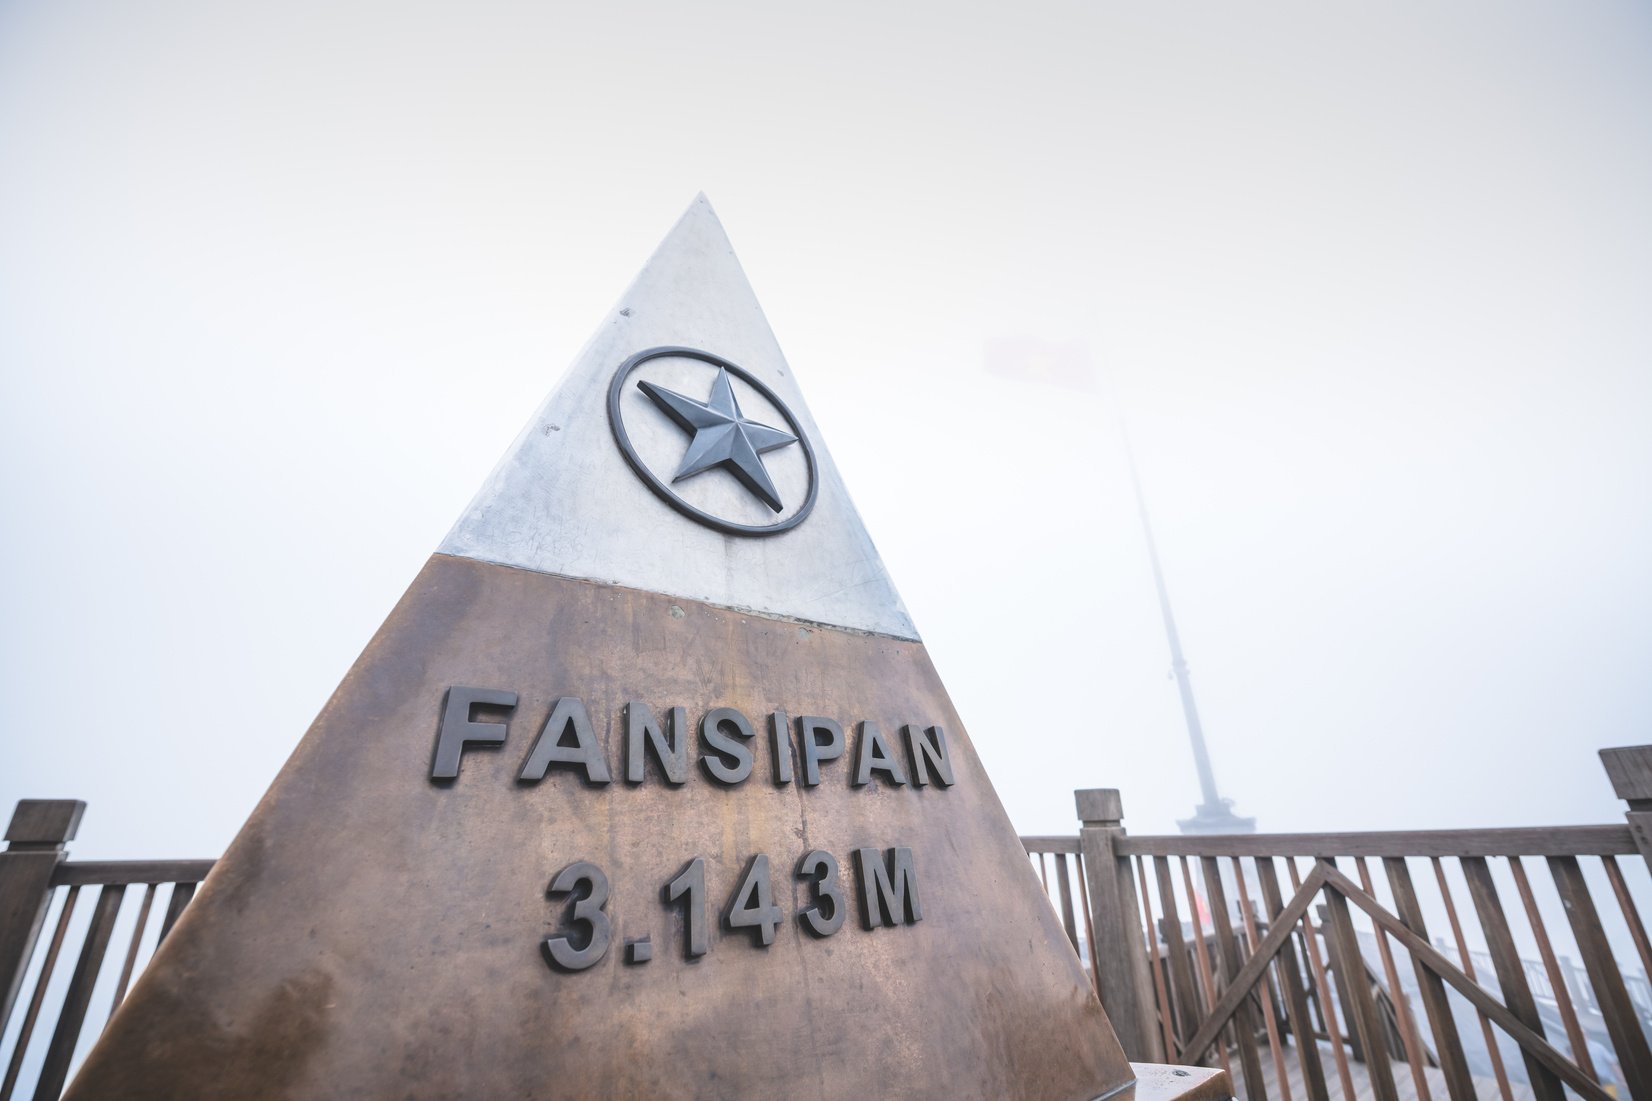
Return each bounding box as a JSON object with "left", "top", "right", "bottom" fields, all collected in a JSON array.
[{"left": 439, "top": 195, "right": 919, "bottom": 640}]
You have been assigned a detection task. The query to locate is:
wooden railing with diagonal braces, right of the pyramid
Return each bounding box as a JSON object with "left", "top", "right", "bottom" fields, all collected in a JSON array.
[{"left": 1023, "top": 747, "right": 1652, "bottom": 1101}]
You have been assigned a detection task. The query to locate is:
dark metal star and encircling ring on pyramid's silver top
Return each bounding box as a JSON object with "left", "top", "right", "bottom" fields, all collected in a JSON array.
[{"left": 608, "top": 346, "right": 819, "bottom": 536}]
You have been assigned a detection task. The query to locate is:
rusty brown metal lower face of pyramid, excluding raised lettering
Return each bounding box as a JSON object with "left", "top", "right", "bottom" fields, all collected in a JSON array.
[{"left": 68, "top": 555, "right": 1132, "bottom": 1101}]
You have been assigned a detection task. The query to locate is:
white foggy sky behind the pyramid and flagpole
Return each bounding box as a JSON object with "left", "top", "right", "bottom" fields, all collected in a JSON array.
[{"left": 0, "top": 0, "right": 1652, "bottom": 858}]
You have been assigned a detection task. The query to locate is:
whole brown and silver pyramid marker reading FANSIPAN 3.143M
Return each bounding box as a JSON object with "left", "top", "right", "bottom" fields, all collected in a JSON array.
[{"left": 68, "top": 197, "right": 1130, "bottom": 1101}]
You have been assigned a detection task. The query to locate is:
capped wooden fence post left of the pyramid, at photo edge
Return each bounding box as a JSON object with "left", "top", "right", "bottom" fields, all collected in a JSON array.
[{"left": 0, "top": 798, "right": 86, "bottom": 1032}]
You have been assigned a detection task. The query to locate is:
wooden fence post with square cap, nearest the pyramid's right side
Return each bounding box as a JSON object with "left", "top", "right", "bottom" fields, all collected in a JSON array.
[{"left": 1074, "top": 787, "right": 1165, "bottom": 1063}]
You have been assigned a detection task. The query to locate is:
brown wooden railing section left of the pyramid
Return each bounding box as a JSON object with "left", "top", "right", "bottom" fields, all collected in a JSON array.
[{"left": 0, "top": 798, "right": 213, "bottom": 1101}]
